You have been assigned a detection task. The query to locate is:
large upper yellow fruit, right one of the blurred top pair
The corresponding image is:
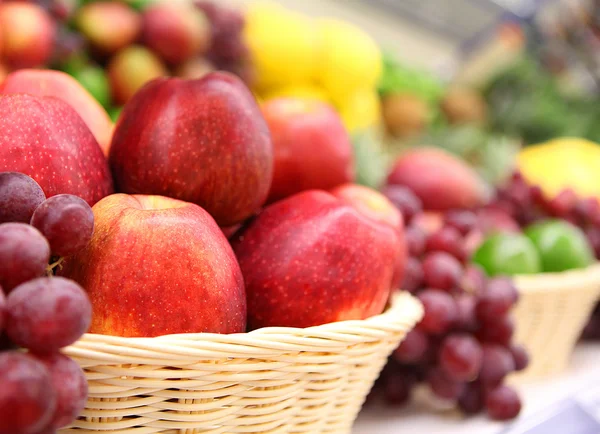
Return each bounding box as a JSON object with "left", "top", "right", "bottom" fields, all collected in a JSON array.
[{"left": 317, "top": 18, "right": 383, "bottom": 104}]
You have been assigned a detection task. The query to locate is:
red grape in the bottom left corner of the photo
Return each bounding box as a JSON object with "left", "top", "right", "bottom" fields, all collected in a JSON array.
[{"left": 0, "top": 351, "right": 56, "bottom": 434}]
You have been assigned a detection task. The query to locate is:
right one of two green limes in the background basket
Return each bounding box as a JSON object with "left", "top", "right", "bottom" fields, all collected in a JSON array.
[{"left": 525, "top": 220, "right": 595, "bottom": 272}]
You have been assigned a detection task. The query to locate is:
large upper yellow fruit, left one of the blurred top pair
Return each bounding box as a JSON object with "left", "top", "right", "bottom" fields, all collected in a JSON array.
[{"left": 244, "top": 2, "right": 318, "bottom": 91}]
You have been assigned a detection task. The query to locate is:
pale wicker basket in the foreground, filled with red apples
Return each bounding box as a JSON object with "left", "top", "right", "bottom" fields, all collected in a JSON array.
[{"left": 60, "top": 293, "right": 422, "bottom": 434}]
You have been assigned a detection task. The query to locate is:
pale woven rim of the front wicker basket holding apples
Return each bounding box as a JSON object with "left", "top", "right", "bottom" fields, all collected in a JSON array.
[{"left": 67, "top": 291, "right": 423, "bottom": 352}]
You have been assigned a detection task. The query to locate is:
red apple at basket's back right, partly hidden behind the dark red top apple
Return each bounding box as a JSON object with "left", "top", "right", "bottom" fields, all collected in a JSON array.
[{"left": 262, "top": 98, "right": 354, "bottom": 202}]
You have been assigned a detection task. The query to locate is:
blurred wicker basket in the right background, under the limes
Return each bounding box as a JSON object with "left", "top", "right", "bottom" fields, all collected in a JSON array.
[{"left": 514, "top": 264, "right": 600, "bottom": 381}]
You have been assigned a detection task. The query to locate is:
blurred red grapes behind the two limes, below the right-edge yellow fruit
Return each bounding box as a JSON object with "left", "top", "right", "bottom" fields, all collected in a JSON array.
[{"left": 488, "top": 172, "right": 600, "bottom": 340}]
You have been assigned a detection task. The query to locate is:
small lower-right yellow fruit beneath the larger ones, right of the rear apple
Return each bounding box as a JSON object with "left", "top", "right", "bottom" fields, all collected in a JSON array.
[{"left": 338, "top": 89, "right": 381, "bottom": 133}]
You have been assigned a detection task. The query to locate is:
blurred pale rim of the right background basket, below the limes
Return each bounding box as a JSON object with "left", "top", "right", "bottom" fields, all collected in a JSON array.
[{"left": 513, "top": 261, "right": 600, "bottom": 292}]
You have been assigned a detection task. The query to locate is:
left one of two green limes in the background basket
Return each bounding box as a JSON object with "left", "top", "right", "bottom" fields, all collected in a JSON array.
[{"left": 472, "top": 232, "right": 542, "bottom": 276}]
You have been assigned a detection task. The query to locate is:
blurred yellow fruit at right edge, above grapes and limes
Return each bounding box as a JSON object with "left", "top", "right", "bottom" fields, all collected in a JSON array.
[{"left": 517, "top": 137, "right": 600, "bottom": 199}]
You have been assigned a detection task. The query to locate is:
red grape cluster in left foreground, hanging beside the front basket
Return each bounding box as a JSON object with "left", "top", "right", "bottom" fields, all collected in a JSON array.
[{"left": 0, "top": 172, "right": 94, "bottom": 434}]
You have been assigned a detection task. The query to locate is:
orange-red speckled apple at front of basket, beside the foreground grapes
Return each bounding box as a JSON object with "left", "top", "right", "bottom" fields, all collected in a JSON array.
[{"left": 59, "top": 194, "right": 246, "bottom": 337}]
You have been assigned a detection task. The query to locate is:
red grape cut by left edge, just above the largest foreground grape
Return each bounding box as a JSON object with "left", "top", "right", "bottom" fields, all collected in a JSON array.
[{"left": 0, "top": 223, "right": 50, "bottom": 293}]
